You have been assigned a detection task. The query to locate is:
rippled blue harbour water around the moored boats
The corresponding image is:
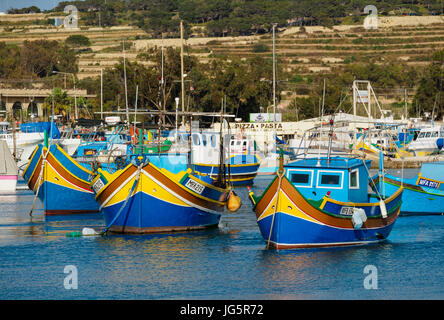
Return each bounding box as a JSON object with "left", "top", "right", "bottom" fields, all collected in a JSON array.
[{"left": 0, "top": 172, "right": 444, "bottom": 300}]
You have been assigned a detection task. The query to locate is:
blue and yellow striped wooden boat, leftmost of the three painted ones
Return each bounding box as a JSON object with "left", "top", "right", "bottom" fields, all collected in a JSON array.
[{"left": 23, "top": 139, "right": 99, "bottom": 215}]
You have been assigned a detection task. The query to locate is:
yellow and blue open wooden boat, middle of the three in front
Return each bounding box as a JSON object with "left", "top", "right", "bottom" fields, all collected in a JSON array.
[{"left": 91, "top": 151, "right": 236, "bottom": 233}]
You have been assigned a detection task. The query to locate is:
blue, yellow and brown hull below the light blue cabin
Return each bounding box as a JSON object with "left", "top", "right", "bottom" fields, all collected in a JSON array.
[{"left": 254, "top": 177, "right": 402, "bottom": 249}]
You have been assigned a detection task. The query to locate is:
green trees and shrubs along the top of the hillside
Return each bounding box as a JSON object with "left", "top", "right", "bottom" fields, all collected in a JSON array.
[{"left": 50, "top": 0, "right": 441, "bottom": 36}]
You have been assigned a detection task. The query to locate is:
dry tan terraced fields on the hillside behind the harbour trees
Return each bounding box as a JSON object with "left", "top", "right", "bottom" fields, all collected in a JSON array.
[{"left": 0, "top": 14, "right": 444, "bottom": 99}]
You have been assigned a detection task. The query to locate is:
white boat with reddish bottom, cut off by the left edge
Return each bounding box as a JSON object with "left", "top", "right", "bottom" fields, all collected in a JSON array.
[{"left": 0, "top": 140, "right": 18, "bottom": 192}]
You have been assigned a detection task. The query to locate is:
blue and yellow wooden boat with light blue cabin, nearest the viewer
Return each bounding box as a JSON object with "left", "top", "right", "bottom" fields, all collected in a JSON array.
[{"left": 250, "top": 151, "right": 403, "bottom": 249}]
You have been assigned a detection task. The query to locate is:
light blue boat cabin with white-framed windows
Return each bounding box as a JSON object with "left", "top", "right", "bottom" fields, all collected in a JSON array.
[{"left": 284, "top": 156, "right": 371, "bottom": 203}]
